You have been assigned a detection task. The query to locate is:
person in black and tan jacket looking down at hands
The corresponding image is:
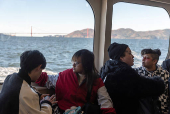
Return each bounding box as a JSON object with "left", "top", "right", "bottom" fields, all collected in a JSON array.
[{"left": 0, "top": 50, "right": 57, "bottom": 114}]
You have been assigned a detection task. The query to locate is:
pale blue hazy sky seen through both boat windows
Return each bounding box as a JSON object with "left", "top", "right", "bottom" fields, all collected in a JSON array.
[{"left": 0, "top": 0, "right": 170, "bottom": 36}]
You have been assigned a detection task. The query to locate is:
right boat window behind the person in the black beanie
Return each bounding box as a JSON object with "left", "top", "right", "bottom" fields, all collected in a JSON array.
[{"left": 111, "top": 2, "right": 170, "bottom": 67}]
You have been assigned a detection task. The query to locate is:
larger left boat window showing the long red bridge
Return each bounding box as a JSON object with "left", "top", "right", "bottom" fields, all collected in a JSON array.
[{"left": 0, "top": 0, "right": 94, "bottom": 81}]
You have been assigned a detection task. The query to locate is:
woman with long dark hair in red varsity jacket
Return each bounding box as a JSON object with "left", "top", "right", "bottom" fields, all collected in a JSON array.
[{"left": 36, "top": 49, "right": 115, "bottom": 114}]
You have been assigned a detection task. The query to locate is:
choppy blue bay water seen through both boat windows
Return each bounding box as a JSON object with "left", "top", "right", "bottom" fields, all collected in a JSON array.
[{"left": 0, "top": 36, "right": 169, "bottom": 80}]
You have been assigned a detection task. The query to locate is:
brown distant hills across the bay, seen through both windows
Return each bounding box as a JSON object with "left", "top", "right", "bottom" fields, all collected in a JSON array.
[{"left": 64, "top": 28, "right": 170, "bottom": 39}]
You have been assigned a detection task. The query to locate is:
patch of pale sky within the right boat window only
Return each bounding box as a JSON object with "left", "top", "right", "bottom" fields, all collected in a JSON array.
[{"left": 112, "top": 3, "right": 170, "bottom": 31}]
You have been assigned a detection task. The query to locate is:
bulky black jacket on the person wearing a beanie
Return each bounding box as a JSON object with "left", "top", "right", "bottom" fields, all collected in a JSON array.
[{"left": 100, "top": 60, "right": 165, "bottom": 114}]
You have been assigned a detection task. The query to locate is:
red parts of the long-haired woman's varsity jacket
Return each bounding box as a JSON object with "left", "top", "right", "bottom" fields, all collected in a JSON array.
[{"left": 36, "top": 69, "right": 115, "bottom": 114}]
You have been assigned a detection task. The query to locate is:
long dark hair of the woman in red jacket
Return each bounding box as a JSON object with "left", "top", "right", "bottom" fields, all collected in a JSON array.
[{"left": 72, "top": 49, "right": 99, "bottom": 89}]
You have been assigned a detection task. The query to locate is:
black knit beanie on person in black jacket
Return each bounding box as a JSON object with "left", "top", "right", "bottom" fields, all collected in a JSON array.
[{"left": 107, "top": 42, "right": 128, "bottom": 60}]
